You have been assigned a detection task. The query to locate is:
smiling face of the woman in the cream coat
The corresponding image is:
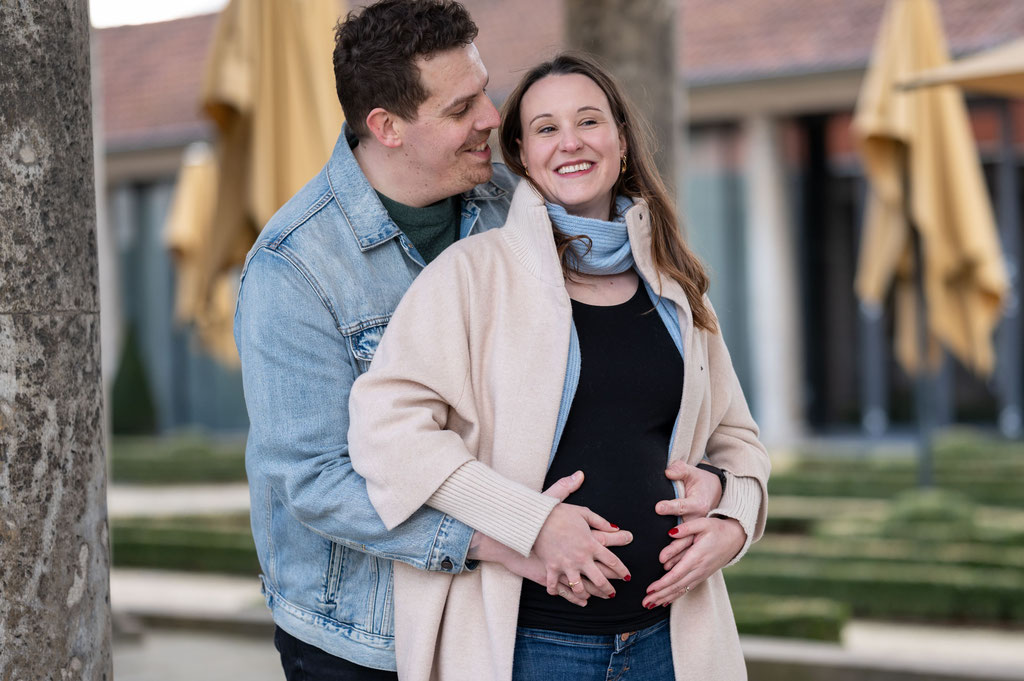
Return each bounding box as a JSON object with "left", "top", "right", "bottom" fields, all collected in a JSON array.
[{"left": 519, "top": 74, "right": 626, "bottom": 220}]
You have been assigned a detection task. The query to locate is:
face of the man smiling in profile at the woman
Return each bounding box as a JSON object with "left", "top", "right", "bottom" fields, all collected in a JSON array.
[{"left": 399, "top": 44, "right": 499, "bottom": 202}]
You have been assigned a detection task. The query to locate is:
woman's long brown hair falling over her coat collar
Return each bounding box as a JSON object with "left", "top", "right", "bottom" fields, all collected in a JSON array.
[{"left": 498, "top": 52, "right": 718, "bottom": 333}]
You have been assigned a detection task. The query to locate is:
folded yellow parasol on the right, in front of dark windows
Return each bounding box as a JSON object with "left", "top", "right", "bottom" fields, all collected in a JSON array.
[{"left": 853, "top": 0, "right": 1008, "bottom": 374}]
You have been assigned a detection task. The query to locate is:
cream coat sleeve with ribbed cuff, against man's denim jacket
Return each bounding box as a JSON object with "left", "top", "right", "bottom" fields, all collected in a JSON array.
[{"left": 348, "top": 249, "right": 558, "bottom": 555}]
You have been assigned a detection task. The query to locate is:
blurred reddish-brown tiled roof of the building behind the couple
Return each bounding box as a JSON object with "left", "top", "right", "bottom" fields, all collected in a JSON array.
[{"left": 97, "top": 0, "right": 1024, "bottom": 150}]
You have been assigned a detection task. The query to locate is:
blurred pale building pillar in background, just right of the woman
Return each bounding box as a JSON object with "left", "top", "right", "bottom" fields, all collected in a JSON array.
[{"left": 743, "top": 115, "right": 804, "bottom": 444}]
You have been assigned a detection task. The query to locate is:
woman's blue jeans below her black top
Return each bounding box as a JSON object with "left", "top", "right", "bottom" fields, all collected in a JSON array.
[{"left": 512, "top": 620, "right": 676, "bottom": 681}]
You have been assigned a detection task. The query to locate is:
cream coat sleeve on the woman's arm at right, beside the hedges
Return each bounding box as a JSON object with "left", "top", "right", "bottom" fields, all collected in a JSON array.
[{"left": 705, "top": 305, "right": 771, "bottom": 565}]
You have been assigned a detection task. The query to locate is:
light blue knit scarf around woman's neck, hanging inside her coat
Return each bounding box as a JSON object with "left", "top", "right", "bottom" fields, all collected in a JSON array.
[{"left": 547, "top": 197, "right": 683, "bottom": 468}]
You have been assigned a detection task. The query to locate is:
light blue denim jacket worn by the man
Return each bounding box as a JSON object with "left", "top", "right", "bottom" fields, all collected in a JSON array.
[{"left": 234, "top": 126, "right": 516, "bottom": 670}]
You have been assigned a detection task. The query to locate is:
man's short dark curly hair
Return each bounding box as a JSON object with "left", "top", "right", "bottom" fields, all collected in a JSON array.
[{"left": 334, "top": 0, "right": 477, "bottom": 138}]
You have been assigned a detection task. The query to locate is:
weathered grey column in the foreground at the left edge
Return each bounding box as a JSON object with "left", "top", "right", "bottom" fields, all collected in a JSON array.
[{"left": 0, "top": 0, "right": 112, "bottom": 681}]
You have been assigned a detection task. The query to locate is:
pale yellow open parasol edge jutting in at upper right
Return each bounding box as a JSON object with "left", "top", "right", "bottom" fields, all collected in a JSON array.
[{"left": 903, "top": 38, "right": 1024, "bottom": 97}]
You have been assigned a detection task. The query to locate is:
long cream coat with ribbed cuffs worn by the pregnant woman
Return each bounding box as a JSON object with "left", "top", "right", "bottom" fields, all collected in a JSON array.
[{"left": 349, "top": 182, "right": 769, "bottom": 681}]
